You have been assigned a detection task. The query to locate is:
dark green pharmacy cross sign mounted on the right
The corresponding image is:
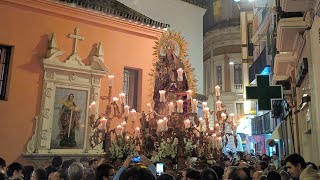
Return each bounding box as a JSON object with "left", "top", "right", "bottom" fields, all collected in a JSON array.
[{"left": 246, "top": 75, "right": 283, "bottom": 111}]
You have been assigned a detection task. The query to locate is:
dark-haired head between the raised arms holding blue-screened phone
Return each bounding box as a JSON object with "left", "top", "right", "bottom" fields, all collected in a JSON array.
[{"left": 119, "top": 165, "right": 156, "bottom": 180}]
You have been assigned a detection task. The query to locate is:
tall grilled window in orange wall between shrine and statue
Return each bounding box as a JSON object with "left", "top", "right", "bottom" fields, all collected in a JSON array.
[{"left": 123, "top": 68, "right": 139, "bottom": 111}]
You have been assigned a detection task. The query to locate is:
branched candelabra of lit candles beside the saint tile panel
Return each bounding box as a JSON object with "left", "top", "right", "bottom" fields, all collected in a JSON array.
[{"left": 89, "top": 75, "right": 136, "bottom": 160}]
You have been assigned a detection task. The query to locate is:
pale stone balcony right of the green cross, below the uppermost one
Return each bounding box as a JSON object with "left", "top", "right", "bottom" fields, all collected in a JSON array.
[{"left": 273, "top": 53, "right": 294, "bottom": 82}]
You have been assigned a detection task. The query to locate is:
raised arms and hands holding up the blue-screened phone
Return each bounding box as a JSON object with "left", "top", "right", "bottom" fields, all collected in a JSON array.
[{"left": 114, "top": 155, "right": 156, "bottom": 180}]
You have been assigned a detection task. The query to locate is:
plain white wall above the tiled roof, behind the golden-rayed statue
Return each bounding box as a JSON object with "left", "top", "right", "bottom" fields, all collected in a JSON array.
[{"left": 118, "top": 0, "right": 206, "bottom": 94}]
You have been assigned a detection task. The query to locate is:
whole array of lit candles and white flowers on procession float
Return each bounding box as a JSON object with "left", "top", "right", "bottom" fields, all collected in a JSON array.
[{"left": 89, "top": 73, "right": 238, "bottom": 169}]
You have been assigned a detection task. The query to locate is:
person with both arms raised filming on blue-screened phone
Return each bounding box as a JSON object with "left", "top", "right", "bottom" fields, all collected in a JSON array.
[{"left": 113, "top": 155, "right": 156, "bottom": 180}]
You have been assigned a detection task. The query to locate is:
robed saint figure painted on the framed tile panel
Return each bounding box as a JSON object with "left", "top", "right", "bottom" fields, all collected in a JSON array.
[{"left": 59, "top": 94, "right": 80, "bottom": 148}]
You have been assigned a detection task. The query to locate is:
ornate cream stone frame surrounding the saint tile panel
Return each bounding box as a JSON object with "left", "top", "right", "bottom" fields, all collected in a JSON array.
[{"left": 24, "top": 31, "right": 108, "bottom": 161}]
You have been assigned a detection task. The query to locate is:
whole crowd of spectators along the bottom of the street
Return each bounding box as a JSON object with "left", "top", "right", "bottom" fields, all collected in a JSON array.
[{"left": 0, "top": 152, "right": 320, "bottom": 180}]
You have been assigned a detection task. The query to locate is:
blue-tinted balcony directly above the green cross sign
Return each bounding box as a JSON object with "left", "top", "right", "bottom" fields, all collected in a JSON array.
[{"left": 249, "top": 47, "right": 270, "bottom": 82}]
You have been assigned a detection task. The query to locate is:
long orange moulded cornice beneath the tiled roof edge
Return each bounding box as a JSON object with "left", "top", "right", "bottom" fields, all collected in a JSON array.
[{"left": 0, "top": 0, "right": 165, "bottom": 39}]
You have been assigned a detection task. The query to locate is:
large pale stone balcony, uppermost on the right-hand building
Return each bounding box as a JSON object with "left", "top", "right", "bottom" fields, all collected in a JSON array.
[{"left": 277, "top": 13, "right": 307, "bottom": 52}]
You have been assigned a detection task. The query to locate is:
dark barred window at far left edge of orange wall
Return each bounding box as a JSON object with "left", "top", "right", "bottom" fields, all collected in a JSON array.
[{"left": 0, "top": 45, "right": 12, "bottom": 100}]
